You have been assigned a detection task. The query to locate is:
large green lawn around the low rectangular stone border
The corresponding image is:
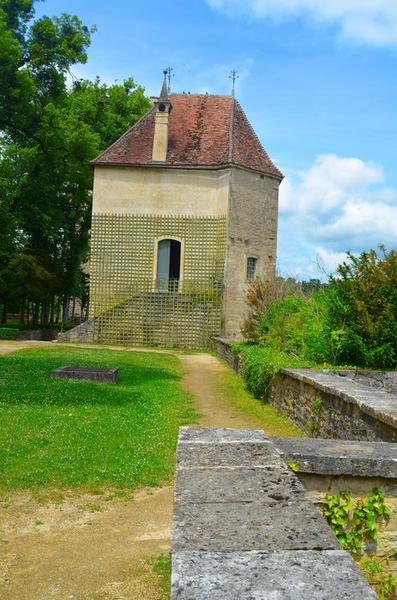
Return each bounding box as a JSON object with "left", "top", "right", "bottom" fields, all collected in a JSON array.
[{"left": 0, "top": 348, "right": 196, "bottom": 489}]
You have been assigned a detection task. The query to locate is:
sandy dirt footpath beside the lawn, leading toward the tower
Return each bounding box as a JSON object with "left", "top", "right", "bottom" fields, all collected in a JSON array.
[{"left": 0, "top": 342, "right": 264, "bottom": 600}]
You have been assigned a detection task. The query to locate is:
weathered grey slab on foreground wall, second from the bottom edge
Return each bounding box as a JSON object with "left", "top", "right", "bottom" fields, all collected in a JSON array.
[{"left": 173, "top": 496, "right": 339, "bottom": 552}]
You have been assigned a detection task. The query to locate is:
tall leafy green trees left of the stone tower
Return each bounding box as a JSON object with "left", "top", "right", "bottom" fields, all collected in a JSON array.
[{"left": 0, "top": 0, "right": 149, "bottom": 320}]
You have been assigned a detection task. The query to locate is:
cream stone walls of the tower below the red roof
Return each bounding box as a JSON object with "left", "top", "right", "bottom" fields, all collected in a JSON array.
[{"left": 87, "top": 166, "right": 279, "bottom": 347}]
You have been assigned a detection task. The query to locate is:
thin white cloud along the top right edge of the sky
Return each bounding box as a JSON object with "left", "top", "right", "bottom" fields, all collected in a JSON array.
[{"left": 207, "top": 0, "right": 397, "bottom": 46}]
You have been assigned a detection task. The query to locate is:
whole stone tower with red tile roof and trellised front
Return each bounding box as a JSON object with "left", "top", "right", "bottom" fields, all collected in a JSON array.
[{"left": 90, "top": 77, "right": 283, "bottom": 347}]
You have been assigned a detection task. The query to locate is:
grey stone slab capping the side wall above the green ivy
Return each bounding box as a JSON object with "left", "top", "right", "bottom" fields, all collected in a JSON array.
[{"left": 271, "top": 437, "right": 397, "bottom": 479}]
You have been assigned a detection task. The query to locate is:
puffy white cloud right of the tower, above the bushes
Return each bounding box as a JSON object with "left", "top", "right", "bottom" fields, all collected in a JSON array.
[{"left": 279, "top": 154, "right": 397, "bottom": 277}]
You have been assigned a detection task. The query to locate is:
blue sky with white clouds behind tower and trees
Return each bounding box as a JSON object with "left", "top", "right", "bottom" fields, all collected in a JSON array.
[{"left": 37, "top": 0, "right": 397, "bottom": 278}]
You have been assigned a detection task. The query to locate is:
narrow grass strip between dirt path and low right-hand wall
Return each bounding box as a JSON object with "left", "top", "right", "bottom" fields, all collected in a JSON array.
[{"left": 220, "top": 371, "right": 305, "bottom": 437}]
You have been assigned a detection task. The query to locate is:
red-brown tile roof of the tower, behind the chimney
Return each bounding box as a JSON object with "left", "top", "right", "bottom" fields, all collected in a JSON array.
[{"left": 93, "top": 94, "right": 283, "bottom": 180}]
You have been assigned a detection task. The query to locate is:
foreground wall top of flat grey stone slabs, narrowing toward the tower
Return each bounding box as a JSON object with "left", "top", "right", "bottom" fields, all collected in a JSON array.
[{"left": 171, "top": 428, "right": 376, "bottom": 600}]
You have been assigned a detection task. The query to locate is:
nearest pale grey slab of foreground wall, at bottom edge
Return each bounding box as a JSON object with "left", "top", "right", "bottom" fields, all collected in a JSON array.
[{"left": 172, "top": 550, "right": 377, "bottom": 600}]
